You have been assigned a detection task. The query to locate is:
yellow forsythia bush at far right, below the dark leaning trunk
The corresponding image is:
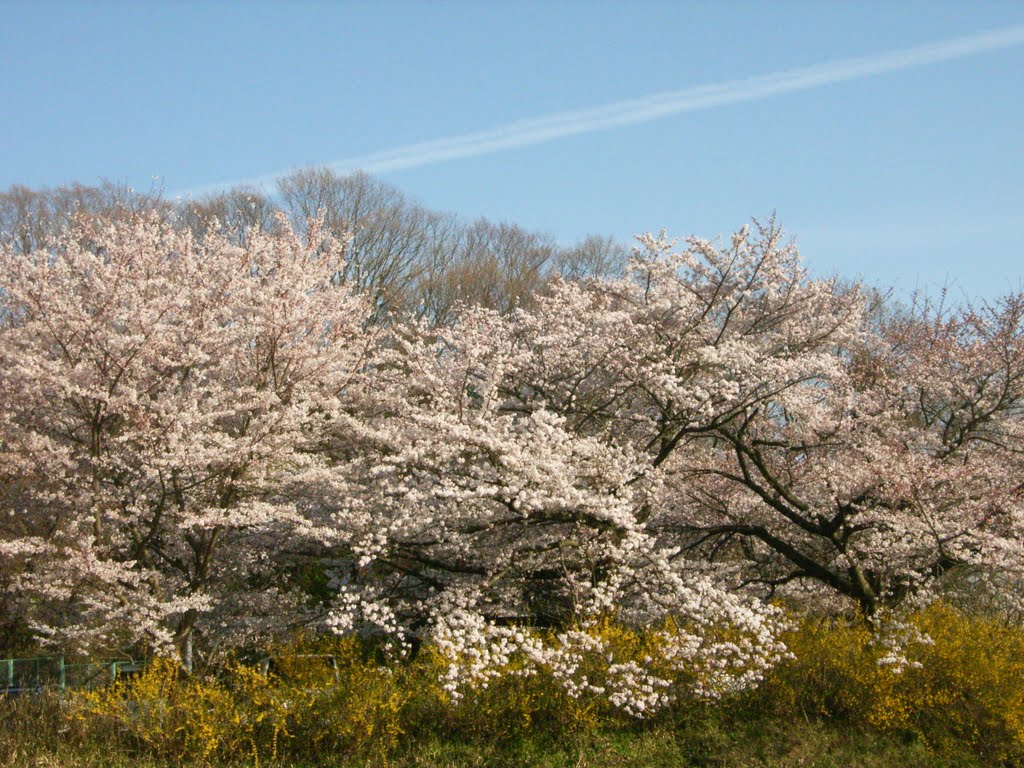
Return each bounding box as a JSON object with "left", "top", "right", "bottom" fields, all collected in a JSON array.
[{"left": 756, "top": 603, "right": 1024, "bottom": 763}]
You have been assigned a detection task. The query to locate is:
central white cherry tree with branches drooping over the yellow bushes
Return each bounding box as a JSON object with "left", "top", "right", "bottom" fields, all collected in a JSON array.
[{"left": 319, "top": 307, "right": 783, "bottom": 714}]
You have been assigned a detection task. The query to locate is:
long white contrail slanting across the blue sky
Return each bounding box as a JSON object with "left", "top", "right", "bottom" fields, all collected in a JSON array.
[{"left": 179, "top": 26, "right": 1024, "bottom": 196}]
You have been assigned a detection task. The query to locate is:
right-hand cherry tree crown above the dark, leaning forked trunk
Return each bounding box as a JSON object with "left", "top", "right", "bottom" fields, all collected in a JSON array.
[{"left": 419, "top": 222, "right": 1024, "bottom": 613}]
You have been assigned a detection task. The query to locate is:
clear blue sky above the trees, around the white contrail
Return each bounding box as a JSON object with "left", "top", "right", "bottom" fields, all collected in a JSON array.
[{"left": 0, "top": 0, "right": 1024, "bottom": 297}]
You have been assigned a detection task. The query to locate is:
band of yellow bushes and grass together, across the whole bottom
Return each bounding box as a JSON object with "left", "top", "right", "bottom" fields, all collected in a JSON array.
[{"left": 0, "top": 604, "right": 1024, "bottom": 768}]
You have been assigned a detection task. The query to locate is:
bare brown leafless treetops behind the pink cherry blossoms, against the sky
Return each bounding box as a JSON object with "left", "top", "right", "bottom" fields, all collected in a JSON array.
[{"left": 0, "top": 168, "right": 630, "bottom": 325}]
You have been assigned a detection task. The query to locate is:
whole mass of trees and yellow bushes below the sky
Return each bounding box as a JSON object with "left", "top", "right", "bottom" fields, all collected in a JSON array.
[{"left": 6, "top": 182, "right": 1024, "bottom": 765}]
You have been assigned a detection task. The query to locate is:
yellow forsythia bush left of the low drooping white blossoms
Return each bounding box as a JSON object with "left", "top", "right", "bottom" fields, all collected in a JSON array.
[{"left": 73, "top": 641, "right": 410, "bottom": 764}]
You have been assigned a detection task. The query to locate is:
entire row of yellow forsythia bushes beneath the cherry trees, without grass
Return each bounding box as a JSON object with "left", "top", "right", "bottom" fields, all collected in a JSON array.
[{"left": 70, "top": 603, "right": 1024, "bottom": 765}]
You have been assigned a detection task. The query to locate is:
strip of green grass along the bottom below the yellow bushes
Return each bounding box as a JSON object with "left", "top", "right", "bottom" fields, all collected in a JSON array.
[{"left": 0, "top": 698, "right": 986, "bottom": 768}]
